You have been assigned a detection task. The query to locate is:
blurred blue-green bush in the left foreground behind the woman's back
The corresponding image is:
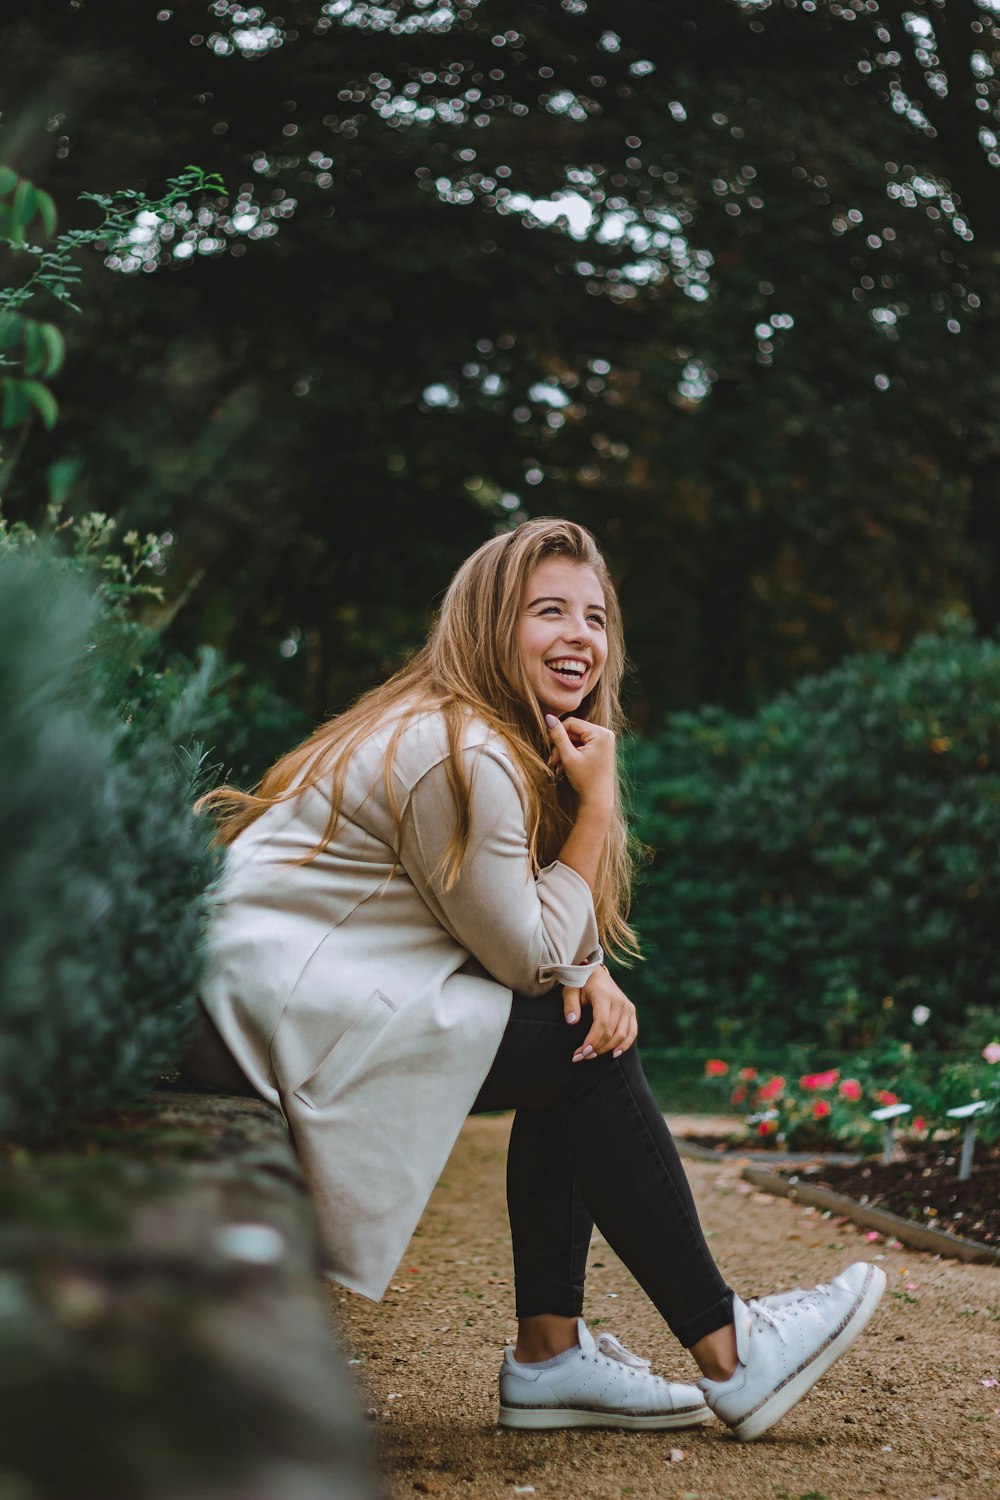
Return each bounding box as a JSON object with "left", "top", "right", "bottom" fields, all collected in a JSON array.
[{"left": 0, "top": 545, "right": 214, "bottom": 1136}]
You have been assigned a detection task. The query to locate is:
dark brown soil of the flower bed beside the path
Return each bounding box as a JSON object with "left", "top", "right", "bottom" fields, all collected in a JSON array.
[{"left": 783, "top": 1145, "right": 1000, "bottom": 1245}]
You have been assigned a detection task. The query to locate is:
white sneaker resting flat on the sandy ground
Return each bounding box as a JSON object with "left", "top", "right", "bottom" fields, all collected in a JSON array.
[{"left": 499, "top": 1319, "right": 712, "bottom": 1431}]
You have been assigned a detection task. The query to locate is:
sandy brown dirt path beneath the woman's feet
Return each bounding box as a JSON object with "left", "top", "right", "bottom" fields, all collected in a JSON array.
[{"left": 331, "top": 1116, "right": 1000, "bottom": 1500}]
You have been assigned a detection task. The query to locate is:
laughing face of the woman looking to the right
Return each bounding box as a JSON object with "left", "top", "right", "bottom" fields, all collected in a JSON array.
[{"left": 517, "top": 557, "right": 607, "bottom": 717}]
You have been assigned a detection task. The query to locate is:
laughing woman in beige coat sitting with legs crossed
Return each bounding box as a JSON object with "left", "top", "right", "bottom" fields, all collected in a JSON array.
[{"left": 190, "top": 521, "right": 885, "bottom": 1439}]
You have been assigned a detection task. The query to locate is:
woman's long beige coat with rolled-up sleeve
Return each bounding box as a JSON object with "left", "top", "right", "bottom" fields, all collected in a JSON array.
[{"left": 202, "top": 714, "right": 601, "bottom": 1299}]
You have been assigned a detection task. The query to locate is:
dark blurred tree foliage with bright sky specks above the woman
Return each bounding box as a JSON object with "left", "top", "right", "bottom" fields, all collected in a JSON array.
[{"left": 0, "top": 0, "right": 1000, "bottom": 728}]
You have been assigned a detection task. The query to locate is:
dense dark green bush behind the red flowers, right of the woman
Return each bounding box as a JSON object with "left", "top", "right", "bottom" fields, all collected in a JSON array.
[{"left": 631, "top": 623, "right": 1000, "bottom": 1056}]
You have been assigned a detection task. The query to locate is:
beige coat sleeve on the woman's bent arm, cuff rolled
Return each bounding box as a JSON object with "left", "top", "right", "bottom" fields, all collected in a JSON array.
[{"left": 400, "top": 749, "right": 604, "bottom": 995}]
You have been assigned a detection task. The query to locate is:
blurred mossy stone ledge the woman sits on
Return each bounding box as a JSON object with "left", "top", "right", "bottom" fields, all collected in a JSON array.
[{"left": 0, "top": 1092, "right": 378, "bottom": 1500}]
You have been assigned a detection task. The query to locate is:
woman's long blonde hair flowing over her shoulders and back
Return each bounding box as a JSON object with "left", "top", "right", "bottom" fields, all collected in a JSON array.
[{"left": 198, "top": 519, "right": 639, "bottom": 960}]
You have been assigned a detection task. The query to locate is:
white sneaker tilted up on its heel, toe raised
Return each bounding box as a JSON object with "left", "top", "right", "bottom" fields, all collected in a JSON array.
[{"left": 699, "top": 1262, "right": 886, "bottom": 1443}]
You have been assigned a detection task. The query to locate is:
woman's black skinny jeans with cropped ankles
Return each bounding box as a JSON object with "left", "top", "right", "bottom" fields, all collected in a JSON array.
[{"left": 472, "top": 990, "right": 733, "bottom": 1349}]
